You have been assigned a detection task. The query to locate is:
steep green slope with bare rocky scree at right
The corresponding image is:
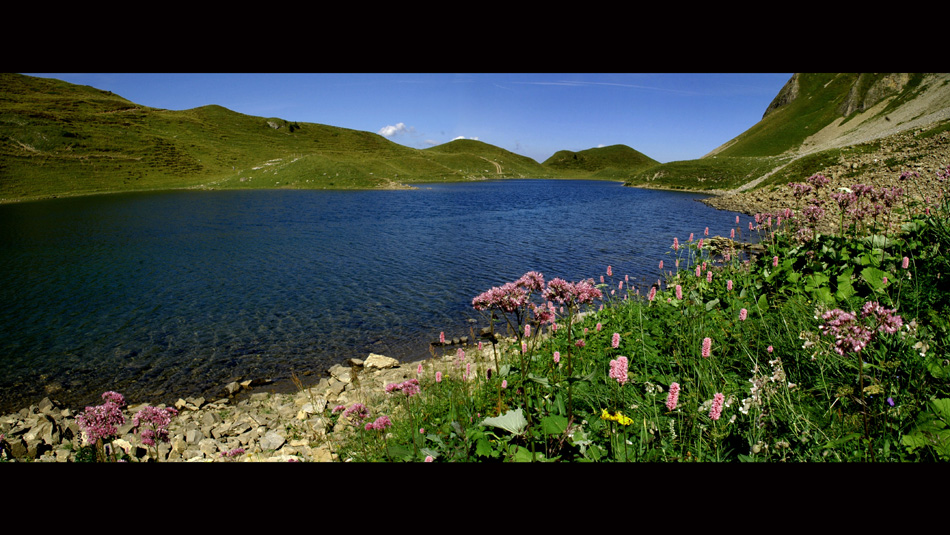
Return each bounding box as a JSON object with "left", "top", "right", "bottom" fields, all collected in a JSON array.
[{"left": 626, "top": 73, "right": 950, "bottom": 190}]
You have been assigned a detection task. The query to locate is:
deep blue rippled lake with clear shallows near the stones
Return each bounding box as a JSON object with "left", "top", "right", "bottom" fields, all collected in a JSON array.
[{"left": 0, "top": 180, "right": 748, "bottom": 412}]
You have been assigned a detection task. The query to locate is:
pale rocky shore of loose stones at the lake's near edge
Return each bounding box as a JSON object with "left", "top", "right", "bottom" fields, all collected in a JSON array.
[{"left": 0, "top": 342, "right": 490, "bottom": 462}]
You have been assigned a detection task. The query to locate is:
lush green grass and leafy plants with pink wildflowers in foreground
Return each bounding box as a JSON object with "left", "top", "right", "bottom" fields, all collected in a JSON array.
[{"left": 329, "top": 168, "right": 950, "bottom": 462}]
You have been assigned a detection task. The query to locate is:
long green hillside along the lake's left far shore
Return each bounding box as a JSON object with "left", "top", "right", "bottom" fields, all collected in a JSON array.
[{"left": 0, "top": 74, "right": 564, "bottom": 201}]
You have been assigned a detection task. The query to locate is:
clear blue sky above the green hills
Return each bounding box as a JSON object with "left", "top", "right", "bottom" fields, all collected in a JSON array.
[{"left": 26, "top": 73, "right": 791, "bottom": 163}]
